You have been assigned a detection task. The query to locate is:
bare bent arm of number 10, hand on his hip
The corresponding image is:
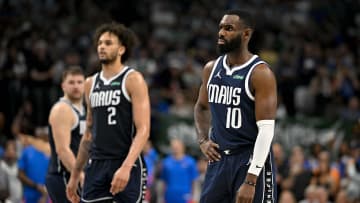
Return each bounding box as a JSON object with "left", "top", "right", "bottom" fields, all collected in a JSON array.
[{"left": 194, "top": 61, "right": 220, "bottom": 161}]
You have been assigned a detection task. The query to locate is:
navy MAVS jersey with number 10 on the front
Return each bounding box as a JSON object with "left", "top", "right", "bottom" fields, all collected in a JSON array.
[{"left": 207, "top": 55, "right": 265, "bottom": 150}]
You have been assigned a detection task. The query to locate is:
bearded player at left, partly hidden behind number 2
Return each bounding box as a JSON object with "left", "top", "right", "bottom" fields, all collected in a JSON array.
[{"left": 46, "top": 66, "right": 86, "bottom": 203}]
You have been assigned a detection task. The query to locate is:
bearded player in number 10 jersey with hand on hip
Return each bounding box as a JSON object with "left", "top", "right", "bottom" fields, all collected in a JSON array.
[{"left": 194, "top": 10, "right": 277, "bottom": 203}]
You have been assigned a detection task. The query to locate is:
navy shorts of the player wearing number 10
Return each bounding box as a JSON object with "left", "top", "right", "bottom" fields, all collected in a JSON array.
[{"left": 200, "top": 147, "right": 277, "bottom": 203}]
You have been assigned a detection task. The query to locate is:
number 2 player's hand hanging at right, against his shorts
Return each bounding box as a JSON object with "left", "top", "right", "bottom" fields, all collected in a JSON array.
[{"left": 110, "top": 166, "right": 132, "bottom": 195}]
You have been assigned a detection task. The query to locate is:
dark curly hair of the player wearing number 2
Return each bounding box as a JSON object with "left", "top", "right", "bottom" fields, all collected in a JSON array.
[{"left": 94, "top": 22, "right": 138, "bottom": 62}]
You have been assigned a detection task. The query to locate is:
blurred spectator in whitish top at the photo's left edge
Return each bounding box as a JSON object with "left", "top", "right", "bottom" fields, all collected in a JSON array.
[{"left": 0, "top": 140, "right": 22, "bottom": 203}]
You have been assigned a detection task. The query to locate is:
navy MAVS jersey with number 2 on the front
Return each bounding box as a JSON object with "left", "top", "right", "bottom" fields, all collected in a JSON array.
[{"left": 89, "top": 66, "right": 135, "bottom": 159}]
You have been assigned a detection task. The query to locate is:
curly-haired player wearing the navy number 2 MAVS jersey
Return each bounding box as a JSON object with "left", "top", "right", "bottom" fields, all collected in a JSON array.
[{"left": 67, "top": 23, "right": 150, "bottom": 203}]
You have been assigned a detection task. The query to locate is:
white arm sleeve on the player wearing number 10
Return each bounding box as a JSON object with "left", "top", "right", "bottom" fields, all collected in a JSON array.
[{"left": 248, "top": 120, "right": 275, "bottom": 176}]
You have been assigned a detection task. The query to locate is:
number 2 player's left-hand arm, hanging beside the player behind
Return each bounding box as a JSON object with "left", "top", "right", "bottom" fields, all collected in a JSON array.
[{"left": 66, "top": 77, "right": 93, "bottom": 203}]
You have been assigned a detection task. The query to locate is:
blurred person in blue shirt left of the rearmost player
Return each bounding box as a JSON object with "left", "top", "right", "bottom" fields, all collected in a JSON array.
[{"left": 18, "top": 128, "right": 49, "bottom": 203}]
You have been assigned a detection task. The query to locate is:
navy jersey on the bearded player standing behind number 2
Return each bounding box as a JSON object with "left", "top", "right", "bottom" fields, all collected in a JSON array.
[{"left": 48, "top": 98, "right": 86, "bottom": 174}]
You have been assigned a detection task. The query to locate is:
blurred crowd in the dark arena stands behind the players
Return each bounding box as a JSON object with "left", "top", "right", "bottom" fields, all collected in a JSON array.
[{"left": 0, "top": 0, "right": 360, "bottom": 203}]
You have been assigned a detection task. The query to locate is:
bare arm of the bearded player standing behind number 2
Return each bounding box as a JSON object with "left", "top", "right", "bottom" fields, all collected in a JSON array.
[{"left": 49, "top": 102, "right": 76, "bottom": 172}]
